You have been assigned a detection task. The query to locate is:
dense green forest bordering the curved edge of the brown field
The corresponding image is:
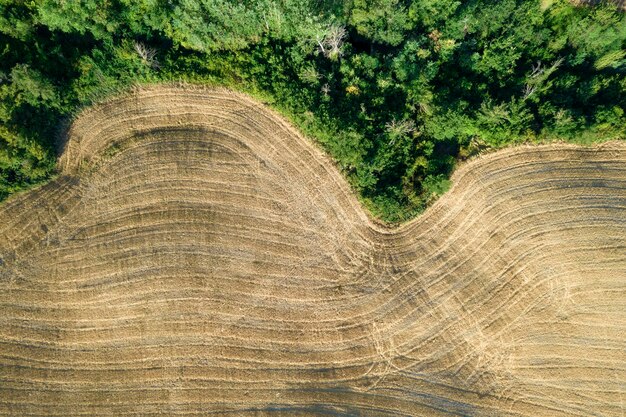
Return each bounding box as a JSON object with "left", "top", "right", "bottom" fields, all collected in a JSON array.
[{"left": 0, "top": 0, "right": 626, "bottom": 222}]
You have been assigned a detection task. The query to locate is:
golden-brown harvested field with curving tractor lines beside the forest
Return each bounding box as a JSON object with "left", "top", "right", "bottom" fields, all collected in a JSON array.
[{"left": 0, "top": 86, "right": 626, "bottom": 417}]
